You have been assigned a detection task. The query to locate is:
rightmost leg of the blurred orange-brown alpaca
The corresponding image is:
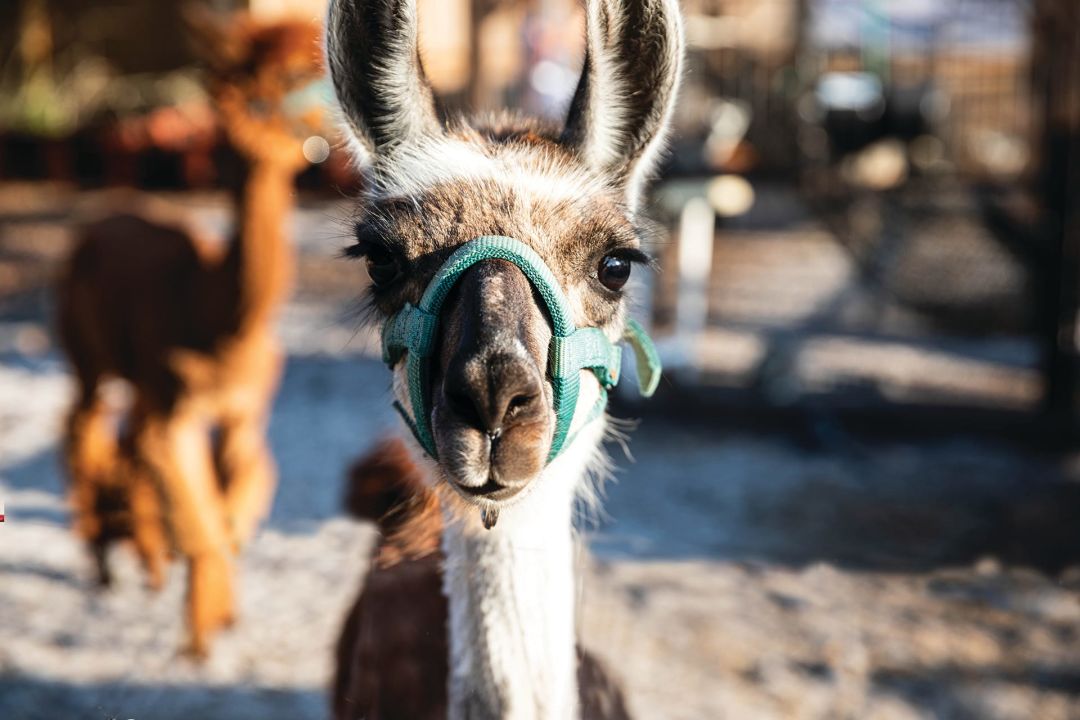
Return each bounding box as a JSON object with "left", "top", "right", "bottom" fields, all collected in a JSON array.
[{"left": 218, "top": 413, "right": 278, "bottom": 548}]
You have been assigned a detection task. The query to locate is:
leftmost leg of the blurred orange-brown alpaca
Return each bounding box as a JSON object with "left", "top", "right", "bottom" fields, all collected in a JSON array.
[{"left": 65, "top": 384, "right": 117, "bottom": 585}]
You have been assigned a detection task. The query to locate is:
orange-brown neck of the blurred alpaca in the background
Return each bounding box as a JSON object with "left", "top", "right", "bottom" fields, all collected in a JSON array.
[{"left": 226, "top": 162, "right": 295, "bottom": 335}]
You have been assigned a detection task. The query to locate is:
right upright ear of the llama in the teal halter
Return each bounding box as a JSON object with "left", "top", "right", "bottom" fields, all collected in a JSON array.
[{"left": 563, "top": 0, "right": 683, "bottom": 207}]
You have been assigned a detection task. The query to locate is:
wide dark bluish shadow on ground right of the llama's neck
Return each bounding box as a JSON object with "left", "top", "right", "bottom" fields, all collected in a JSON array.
[{"left": 595, "top": 419, "right": 1080, "bottom": 572}]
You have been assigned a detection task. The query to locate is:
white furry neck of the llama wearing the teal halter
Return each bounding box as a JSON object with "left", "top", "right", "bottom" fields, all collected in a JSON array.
[{"left": 443, "top": 464, "right": 578, "bottom": 720}]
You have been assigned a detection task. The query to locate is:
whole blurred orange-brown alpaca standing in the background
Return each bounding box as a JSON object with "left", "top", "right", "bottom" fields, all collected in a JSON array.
[{"left": 58, "top": 13, "right": 322, "bottom": 655}]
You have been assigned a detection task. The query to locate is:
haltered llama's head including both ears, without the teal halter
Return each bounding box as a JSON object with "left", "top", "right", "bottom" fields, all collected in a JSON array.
[{"left": 326, "top": 0, "right": 683, "bottom": 510}]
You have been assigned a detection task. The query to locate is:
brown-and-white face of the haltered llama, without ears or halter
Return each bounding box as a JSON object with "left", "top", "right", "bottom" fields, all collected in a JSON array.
[{"left": 355, "top": 133, "right": 646, "bottom": 500}]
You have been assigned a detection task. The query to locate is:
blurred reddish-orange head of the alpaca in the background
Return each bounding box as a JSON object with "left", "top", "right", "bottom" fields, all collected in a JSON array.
[{"left": 185, "top": 4, "right": 327, "bottom": 169}]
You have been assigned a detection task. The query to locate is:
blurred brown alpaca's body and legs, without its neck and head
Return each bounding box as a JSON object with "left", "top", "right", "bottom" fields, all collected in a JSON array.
[{"left": 58, "top": 166, "right": 292, "bottom": 653}]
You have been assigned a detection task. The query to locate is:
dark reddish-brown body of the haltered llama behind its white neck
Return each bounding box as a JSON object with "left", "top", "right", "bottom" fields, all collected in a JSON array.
[{"left": 332, "top": 439, "right": 630, "bottom": 720}]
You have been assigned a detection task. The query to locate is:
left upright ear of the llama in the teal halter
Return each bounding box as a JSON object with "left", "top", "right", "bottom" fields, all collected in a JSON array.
[{"left": 326, "top": 0, "right": 442, "bottom": 161}]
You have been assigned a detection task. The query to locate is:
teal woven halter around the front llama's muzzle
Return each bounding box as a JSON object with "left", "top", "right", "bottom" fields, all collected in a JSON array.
[{"left": 382, "top": 235, "right": 661, "bottom": 462}]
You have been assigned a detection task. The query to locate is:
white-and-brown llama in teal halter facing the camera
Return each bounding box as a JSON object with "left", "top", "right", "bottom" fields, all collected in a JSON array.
[{"left": 326, "top": 0, "right": 683, "bottom": 720}]
